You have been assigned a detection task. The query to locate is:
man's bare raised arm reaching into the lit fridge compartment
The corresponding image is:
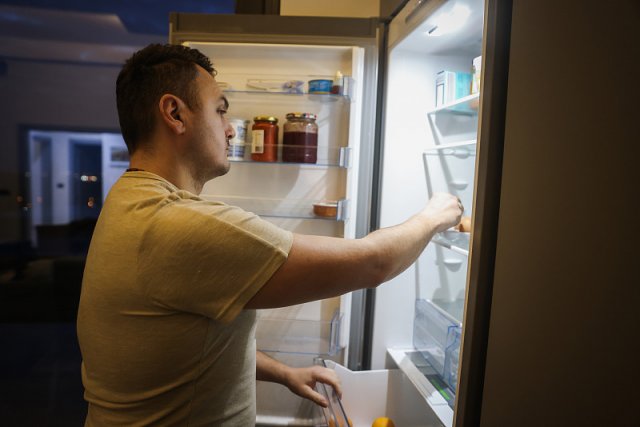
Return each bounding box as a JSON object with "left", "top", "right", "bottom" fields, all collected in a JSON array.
[{"left": 245, "top": 194, "right": 462, "bottom": 309}]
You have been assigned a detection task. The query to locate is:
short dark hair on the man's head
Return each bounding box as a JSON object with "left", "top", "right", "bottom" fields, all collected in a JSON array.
[{"left": 116, "top": 44, "right": 216, "bottom": 154}]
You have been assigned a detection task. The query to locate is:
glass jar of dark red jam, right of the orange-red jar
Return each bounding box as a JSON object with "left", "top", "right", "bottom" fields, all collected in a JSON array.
[{"left": 282, "top": 113, "right": 318, "bottom": 163}]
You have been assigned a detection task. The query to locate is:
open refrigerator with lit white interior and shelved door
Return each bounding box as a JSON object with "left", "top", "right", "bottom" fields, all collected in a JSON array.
[{"left": 170, "top": 0, "right": 640, "bottom": 426}]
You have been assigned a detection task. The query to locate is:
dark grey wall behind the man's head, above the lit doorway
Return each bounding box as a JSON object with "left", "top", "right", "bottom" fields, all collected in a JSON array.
[{"left": 0, "top": 59, "right": 119, "bottom": 241}]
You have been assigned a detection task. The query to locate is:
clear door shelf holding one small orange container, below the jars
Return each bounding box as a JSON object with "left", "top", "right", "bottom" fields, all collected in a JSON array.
[{"left": 200, "top": 194, "right": 349, "bottom": 221}]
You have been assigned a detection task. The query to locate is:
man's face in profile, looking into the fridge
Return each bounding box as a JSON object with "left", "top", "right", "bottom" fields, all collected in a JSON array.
[{"left": 189, "top": 67, "right": 234, "bottom": 180}]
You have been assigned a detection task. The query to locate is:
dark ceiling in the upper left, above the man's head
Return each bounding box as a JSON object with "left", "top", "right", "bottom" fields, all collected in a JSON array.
[{"left": 0, "top": 0, "right": 235, "bottom": 64}]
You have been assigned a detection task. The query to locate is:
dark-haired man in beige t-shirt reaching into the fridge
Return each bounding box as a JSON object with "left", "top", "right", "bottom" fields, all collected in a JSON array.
[{"left": 78, "top": 45, "right": 461, "bottom": 426}]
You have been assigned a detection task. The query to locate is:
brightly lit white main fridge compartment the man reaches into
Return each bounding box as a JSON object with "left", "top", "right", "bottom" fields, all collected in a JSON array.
[{"left": 373, "top": 0, "right": 484, "bottom": 426}]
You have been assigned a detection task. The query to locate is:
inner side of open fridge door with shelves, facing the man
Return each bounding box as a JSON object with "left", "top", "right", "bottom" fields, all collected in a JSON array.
[{"left": 182, "top": 42, "right": 364, "bottom": 425}]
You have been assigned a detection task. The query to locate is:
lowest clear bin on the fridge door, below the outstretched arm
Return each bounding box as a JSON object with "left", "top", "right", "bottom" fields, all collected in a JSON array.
[{"left": 256, "top": 312, "right": 342, "bottom": 356}]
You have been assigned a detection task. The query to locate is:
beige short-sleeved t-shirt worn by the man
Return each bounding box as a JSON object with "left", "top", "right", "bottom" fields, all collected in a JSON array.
[{"left": 78, "top": 171, "right": 292, "bottom": 427}]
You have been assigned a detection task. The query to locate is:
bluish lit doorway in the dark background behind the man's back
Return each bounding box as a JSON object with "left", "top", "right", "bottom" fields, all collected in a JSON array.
[{"left": 24, "top": 129, "right": 129, "bottom": 252}]
